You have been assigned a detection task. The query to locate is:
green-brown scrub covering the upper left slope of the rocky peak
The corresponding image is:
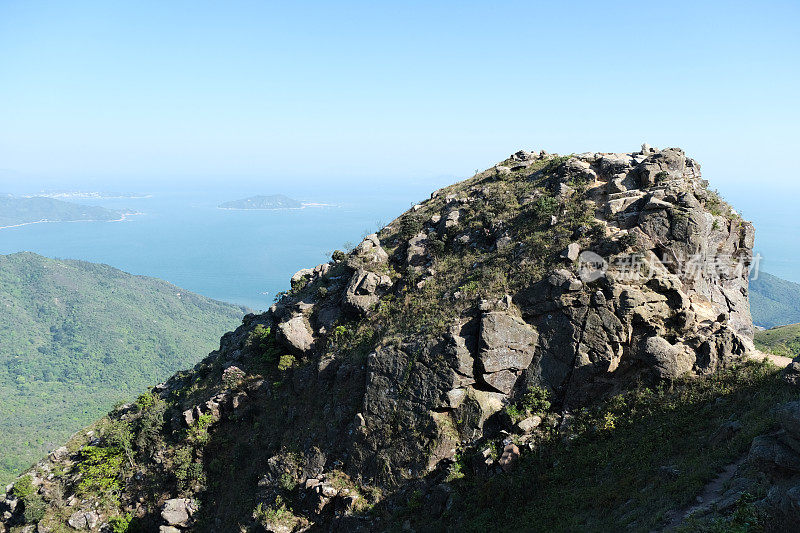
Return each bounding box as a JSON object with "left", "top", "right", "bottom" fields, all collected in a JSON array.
[{"left": 318, "top": 157, "right": 594, "bottom": 348}]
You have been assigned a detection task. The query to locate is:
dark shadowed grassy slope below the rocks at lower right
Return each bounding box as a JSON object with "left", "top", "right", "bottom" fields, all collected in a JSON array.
[{"left": 412, "top": 363, "right": 800, "bottom": 532}]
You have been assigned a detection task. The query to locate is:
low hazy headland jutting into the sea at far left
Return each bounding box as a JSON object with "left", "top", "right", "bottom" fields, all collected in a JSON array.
[{"left": 0, "top": 196, "right": 123, "bottom": 228}]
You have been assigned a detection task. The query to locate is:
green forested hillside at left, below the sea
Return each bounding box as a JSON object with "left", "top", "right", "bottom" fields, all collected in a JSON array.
[{"left": 0, "top": 253, "right": 244, "bottom": 484}]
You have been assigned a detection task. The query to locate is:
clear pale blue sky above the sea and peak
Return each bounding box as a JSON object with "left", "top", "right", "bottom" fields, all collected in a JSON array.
[{"left": 0, "top": 0, "right": 800, "bottom": 186}]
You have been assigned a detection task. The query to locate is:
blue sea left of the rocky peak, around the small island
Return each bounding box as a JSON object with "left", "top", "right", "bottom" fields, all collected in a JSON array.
[{"left": 0, "top": 179, "right": 451, "bottom": 310}]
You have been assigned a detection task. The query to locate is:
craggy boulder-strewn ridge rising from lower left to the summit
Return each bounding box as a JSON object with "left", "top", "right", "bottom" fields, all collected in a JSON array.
[{"left": 0, "top": 145, "right": 780, "bottom": 533}]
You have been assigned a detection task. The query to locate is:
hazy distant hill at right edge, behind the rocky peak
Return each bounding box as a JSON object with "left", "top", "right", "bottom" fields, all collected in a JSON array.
[{"left": 750, "top": 272, "right": 800, "bottom": 328}]
